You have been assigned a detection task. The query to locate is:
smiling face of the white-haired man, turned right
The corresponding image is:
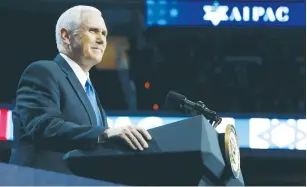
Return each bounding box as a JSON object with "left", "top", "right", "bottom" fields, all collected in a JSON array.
[{"left": 70, "top": 12, "right": 107, "bottom": 68}]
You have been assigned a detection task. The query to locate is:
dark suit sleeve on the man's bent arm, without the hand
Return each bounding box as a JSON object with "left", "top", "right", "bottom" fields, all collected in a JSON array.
[{"left": 16, "top": 62, "right": 104, "bottom": 151}]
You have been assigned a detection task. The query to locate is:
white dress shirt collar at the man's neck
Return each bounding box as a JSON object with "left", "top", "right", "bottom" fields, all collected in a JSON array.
[{"left": 60, "top": 53, "right": 90, "bottom": 89}]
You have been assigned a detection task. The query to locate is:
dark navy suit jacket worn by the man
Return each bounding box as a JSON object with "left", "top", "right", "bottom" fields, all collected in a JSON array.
[{"left": 10, "top": 54, "right": 107, "bottom": 173}]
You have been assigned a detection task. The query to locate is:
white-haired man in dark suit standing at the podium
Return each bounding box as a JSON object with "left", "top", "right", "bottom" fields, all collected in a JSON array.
[{"left": 10, "top": 6, "right": 151, "bottom": 173}]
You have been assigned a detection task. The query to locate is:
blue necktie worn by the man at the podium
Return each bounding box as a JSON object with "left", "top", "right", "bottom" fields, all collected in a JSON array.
[{"left": 85, "top": 80, "right": 102, "bottom": 126}]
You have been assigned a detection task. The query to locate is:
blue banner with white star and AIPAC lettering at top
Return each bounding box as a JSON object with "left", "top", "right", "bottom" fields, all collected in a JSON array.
[{"left": 146, "top": 0, "right": 306, "bottom": 27}]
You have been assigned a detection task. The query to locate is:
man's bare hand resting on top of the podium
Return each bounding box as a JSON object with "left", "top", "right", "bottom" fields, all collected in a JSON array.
[{"left": 104, "top": 125, "right": 151, "bottom": 151}]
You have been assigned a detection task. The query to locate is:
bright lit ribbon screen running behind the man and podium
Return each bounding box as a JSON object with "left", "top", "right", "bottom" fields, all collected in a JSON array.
[{"left": 0, "top": 109, "right": 307, "bottom": 150}]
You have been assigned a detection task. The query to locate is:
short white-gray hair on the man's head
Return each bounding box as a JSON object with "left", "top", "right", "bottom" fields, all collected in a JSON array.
[{"left": 55, "top": 5, "right": 101, "bottom": 50}]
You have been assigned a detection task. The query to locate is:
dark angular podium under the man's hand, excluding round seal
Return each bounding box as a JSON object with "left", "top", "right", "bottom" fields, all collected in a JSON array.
[{"left": 64, "top": 115, "right": 244, "bottom": 186}]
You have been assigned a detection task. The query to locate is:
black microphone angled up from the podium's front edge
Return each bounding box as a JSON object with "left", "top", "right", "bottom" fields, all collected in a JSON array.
[{"left": 166, "top": 91, "right": 222, "bottom": 127}]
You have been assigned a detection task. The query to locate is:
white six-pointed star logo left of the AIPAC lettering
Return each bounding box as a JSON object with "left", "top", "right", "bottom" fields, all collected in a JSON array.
[{"left": 203, "top": 5, "right": 228, "bottom": 26}]
